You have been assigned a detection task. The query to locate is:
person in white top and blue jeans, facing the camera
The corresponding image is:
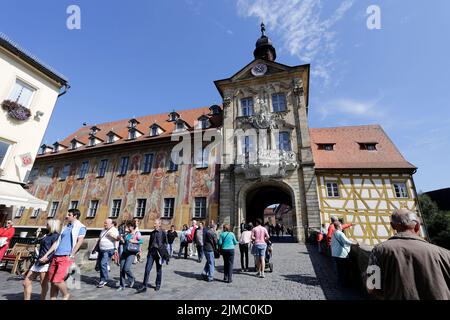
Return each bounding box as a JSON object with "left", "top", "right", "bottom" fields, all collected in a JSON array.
[{"left": 97, "top": 219, "right": 119, "bottom": 288}]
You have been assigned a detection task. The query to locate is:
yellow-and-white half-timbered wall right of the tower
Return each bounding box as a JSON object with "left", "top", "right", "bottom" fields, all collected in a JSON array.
[{"left": 317, "top": 173, "right": 424, "bottom": 245}]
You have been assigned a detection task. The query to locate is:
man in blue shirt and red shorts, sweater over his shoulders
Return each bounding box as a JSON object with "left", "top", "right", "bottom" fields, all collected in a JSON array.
[{"left": 40, "top": 209, "right": 86, "bottom": 300}]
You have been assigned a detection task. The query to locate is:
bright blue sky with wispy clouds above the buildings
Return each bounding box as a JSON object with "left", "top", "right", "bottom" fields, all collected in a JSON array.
[{"left": 0, "top": 0, "right": 450, "bottom": 191}]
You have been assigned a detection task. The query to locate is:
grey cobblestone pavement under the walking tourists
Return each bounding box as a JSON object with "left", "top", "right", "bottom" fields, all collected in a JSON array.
[{"left": 0, "top": 243, "right": 366, "bottom": 300}]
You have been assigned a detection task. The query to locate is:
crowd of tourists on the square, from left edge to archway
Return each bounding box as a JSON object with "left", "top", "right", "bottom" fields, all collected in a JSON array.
[{"left": 0, "top": 209, "right": 270, "bottom": 300}]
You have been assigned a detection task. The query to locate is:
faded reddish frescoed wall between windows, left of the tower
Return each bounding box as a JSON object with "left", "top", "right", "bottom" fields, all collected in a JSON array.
[{"left": 16, "top": 145, "right": 219, "bottom": 229}]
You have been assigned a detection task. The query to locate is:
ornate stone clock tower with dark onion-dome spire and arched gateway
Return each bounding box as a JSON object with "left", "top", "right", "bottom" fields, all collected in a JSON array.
[{"left": 214, "top": 24, "right": 320, "bottom": 241}]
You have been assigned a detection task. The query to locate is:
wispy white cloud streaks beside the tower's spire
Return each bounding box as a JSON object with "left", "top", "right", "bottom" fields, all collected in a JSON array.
[{"left": 237, "top": 0, "right": 354, "bottom": 84}]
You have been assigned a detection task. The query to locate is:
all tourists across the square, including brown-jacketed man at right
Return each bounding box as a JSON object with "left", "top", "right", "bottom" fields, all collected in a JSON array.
[{"left": 0, "top": 205, "right": 450, "bottom": 300}]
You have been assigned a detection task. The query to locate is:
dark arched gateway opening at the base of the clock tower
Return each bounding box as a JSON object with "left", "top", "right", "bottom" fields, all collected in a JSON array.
[{"left": 236, "top": 180, "right": 301, "bottom": 241}]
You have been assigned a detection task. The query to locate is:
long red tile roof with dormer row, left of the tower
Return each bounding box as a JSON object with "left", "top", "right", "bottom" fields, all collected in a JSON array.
[{"left": 39, "top": 107, "right": 222, "bottom": 157}]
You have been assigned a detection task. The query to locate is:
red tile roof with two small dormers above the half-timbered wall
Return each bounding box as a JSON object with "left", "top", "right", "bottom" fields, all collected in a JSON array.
[{"left": 309, "top": 125, "right": 416, "bottom": 169}]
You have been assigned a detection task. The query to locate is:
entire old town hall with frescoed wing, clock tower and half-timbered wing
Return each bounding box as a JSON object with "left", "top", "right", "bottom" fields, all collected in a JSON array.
[{"left": 13, "top": 25, "right": 418, "bottom": 244}]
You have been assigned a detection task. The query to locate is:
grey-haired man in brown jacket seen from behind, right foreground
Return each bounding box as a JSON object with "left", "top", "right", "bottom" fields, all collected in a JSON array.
[{"left": 366, "top": 209, "right": 450, "bottom": 300}]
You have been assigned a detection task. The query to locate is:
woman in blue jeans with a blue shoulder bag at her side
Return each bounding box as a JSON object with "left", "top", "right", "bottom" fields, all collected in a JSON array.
[{"left": 117, "top": 220, "right": 143, "bottom": 291}]
